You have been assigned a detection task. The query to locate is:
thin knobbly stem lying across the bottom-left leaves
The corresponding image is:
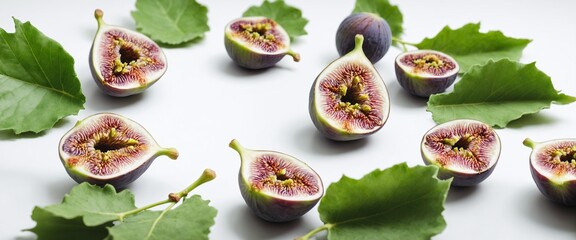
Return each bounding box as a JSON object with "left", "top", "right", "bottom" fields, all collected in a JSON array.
[{"left": 118, "top": 168, "right": 216, "bottom": 221}]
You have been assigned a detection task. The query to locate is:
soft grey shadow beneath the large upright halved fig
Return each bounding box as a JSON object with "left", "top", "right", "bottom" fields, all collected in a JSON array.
[{"left": 293, "top": 125, "right": 369, "bottom": 155}]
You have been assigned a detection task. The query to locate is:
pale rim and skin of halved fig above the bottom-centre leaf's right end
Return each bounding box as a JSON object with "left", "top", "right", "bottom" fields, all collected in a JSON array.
[{"left": 420, "top": 119, "right": 501, "bottom": 187}]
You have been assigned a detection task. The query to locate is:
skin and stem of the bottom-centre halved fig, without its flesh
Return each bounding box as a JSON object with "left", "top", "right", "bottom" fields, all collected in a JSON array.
[{"left": 229, "top": 139, "right": 324, "bottom": 223}]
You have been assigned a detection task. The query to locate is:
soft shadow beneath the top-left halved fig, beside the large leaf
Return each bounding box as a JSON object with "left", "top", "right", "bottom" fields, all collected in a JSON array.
[{"left": 86, "top": 88, "right": 146, "bottom": 111}]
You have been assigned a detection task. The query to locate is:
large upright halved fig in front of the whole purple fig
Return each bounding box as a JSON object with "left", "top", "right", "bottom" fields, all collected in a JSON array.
[{"left": 308, "top": 35, "right": 390, "bottom": 141}]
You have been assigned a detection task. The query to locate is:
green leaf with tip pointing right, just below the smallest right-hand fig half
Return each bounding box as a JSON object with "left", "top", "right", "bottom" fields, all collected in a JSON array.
[{"left": 427, "top": 59, "right": 576, "bottom": 127}]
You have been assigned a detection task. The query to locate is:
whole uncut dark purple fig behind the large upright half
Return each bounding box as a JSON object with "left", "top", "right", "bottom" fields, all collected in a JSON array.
[{"left": 336, "top": 12, "right": 392, "bottom": 63}]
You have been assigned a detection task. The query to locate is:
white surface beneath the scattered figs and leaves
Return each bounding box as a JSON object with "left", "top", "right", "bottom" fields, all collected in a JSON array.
[{"left": 0, "top": 0, "right": 576, "bottom": 240}]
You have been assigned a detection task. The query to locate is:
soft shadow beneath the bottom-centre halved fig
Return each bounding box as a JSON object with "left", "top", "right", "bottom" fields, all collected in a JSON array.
[{"left": 228, "top": 205, "right": 304, "bottom": 240}]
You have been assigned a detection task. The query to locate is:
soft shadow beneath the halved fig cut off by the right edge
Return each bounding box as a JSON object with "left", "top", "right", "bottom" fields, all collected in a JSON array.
[{"left": 521, "top": 191, "right": 576, "bottom": 234}]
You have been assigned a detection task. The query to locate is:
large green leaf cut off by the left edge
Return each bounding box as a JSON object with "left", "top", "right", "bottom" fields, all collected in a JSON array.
[{"left": 0, "top": 18, "right": 86, "bottom": 134}]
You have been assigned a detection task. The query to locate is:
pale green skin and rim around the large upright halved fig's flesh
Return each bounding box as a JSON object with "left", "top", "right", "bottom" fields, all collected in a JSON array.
[{"left": 308, "top": 35, "right": 390, "bottom": 141}]
